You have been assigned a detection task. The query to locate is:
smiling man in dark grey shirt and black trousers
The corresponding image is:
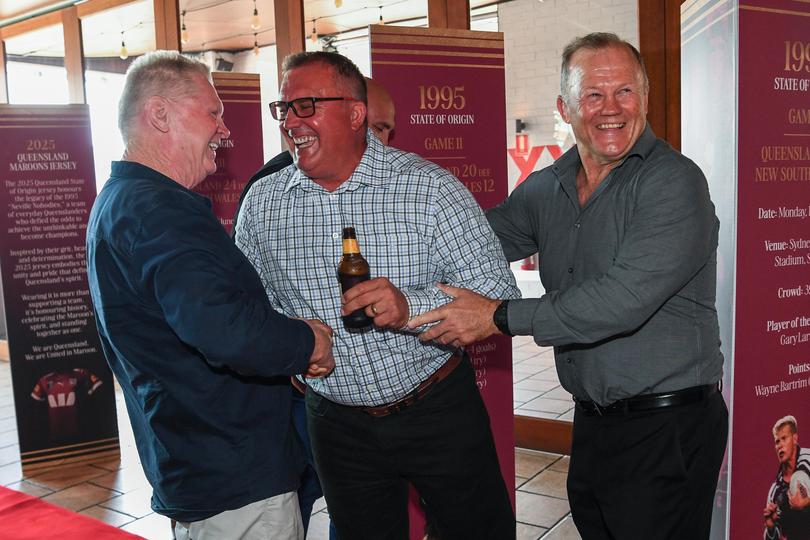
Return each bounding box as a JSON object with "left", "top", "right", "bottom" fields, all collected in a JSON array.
[{"left": 409, "top": 33, "right": 728, "bottom": 539}]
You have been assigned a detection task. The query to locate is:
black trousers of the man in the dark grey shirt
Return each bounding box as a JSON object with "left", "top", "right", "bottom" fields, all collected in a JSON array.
[{"left": 568, "top": 392, "right": 728, "bottom": 540}]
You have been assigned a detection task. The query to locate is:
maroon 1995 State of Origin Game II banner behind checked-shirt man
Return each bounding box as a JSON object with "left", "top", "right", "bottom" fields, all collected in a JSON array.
[{"left": 370, "top": 25, "right": 515, "bottom": 539}]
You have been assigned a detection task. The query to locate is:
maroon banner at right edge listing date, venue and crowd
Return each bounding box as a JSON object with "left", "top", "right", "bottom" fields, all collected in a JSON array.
[{"left": 729, "top": 0, "right": 810, "bottom": 540}]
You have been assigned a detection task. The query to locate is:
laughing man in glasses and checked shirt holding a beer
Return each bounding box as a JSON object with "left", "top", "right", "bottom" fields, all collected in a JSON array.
[{"left": 236, "top": 52, "right": 519, "bottom": 540}]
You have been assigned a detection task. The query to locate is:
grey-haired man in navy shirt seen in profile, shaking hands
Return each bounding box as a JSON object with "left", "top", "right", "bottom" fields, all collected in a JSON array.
[{"left": 87, "top": 51, "right": 334, "bottom": 540}]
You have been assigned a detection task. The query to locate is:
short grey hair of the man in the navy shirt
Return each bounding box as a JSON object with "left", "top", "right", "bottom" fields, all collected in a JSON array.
[{"left": 118, "top": 51, "right": 211, "bottom": 144}]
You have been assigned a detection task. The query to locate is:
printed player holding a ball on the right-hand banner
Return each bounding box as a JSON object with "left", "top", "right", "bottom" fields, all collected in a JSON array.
[{"left": 762, "top": 416, "right": 810, "bottom": 540}]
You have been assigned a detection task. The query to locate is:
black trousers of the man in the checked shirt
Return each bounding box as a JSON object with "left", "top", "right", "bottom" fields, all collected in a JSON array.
[{"left": 307, "top": 359, "right": 515, "bottom": 540}]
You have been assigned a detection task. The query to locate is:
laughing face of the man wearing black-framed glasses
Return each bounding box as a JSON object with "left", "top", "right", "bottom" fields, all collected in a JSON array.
[{"left": 279, "top": 62, "right": 366, "bottom": 189}]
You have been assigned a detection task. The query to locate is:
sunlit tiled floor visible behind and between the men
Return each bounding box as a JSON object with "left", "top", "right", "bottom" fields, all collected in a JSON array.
[{"left": 0, "top": 337, "right": 580, "bottom": 540}]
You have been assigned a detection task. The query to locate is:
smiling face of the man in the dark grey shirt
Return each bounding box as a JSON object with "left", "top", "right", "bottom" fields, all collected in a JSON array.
[{"left": 557, "top": 46, "right": 647, "bottom": 170}]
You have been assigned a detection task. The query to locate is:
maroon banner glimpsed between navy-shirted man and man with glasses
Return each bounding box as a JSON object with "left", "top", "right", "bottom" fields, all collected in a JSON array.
[{"left": 194, "top": 72, "right": 264, "bottom": 233}]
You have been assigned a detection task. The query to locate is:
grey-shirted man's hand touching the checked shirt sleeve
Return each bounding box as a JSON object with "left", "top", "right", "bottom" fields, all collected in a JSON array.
[{"left": 408, "top": 283, "right": 501, "bottom": 347}]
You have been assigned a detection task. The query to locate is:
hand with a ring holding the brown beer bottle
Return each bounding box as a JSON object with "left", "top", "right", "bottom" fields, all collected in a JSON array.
[{"left": 340, "top": 277, "right": 410, "bottom": 330}]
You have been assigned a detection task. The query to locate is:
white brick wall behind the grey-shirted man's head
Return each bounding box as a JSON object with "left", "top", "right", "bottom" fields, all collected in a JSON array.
[{"left": 498, "top": 0, "right": 638, "bottom": 191}]
